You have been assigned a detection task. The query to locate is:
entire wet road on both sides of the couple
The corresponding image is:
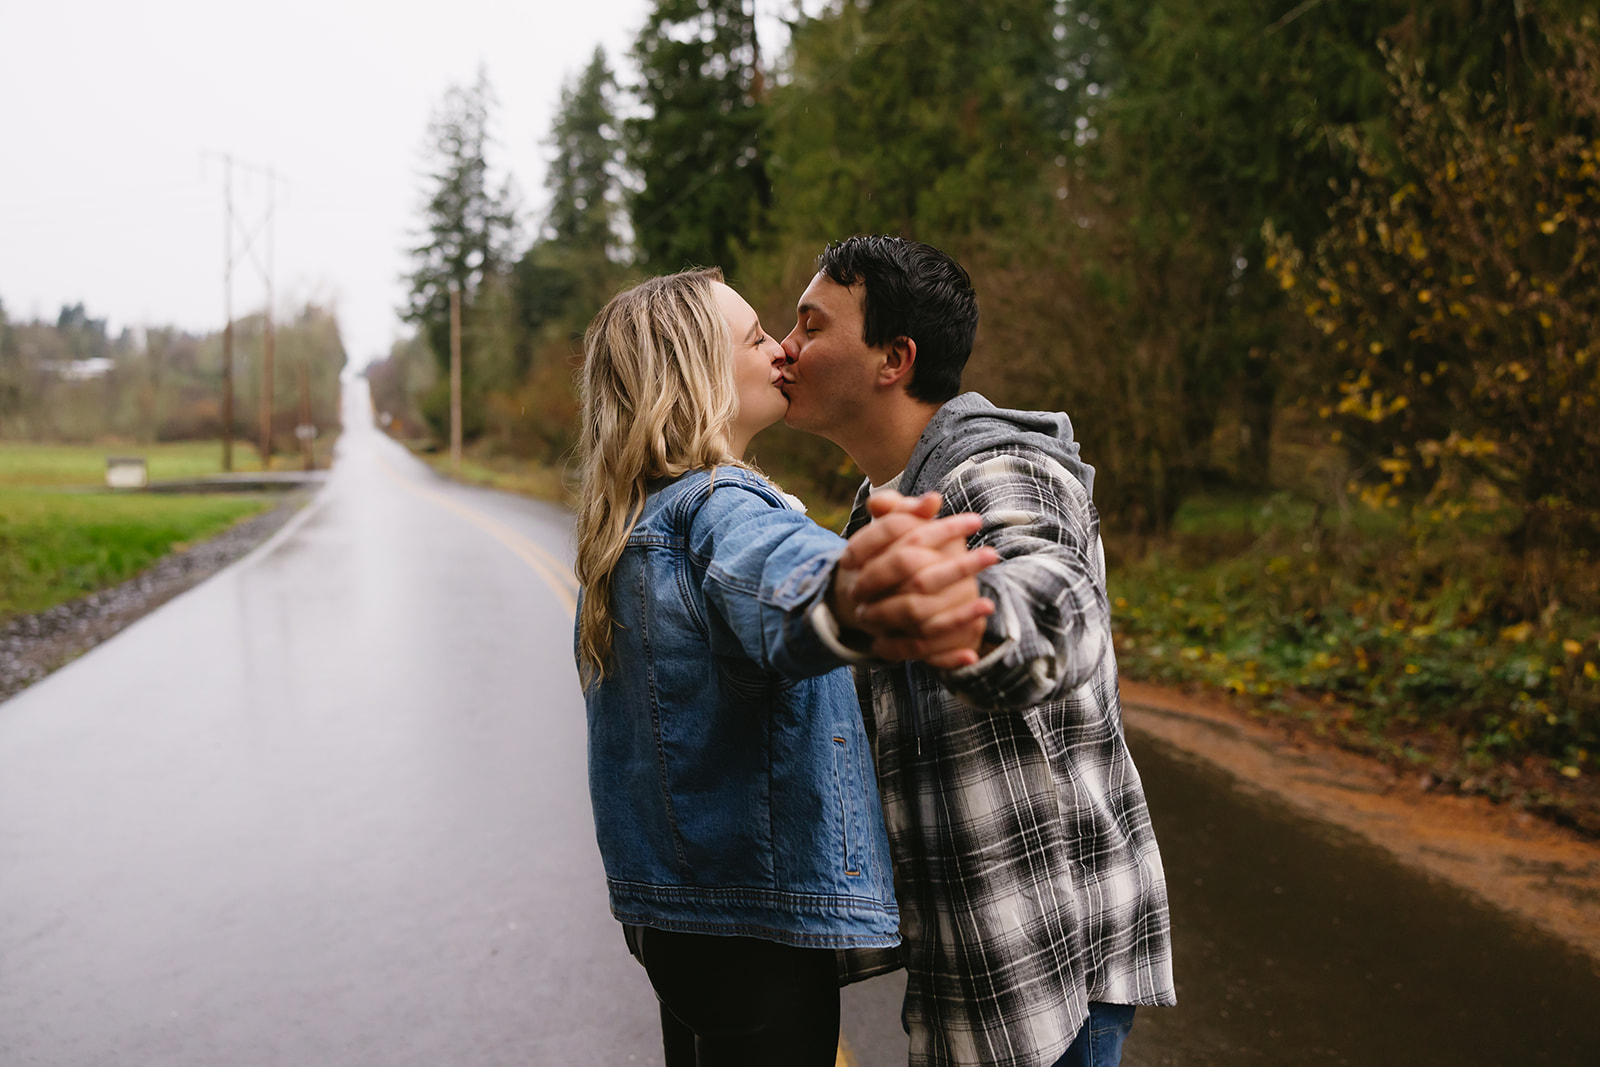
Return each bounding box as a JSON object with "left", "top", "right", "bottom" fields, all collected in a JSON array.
[{"left": 0, "top": 382, "right": 1600, "bottom": 1067}]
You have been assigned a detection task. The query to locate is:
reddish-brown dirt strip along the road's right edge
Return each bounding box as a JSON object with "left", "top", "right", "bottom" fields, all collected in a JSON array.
[{"left": 1122, "top": 680, "right": 1600, "bottom": 966}]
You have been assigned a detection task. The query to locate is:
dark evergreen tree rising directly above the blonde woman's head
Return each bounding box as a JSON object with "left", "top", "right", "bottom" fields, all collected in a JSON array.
[{"left": 626, "top": 0, "right": 771, "bottom": 272}]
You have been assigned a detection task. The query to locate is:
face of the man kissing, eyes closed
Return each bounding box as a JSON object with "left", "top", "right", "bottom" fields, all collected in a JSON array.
[{"left": 782, "top": 274, "right": 883, "bottom": 443}]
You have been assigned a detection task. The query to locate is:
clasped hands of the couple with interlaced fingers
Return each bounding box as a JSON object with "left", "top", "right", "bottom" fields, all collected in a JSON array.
[{"left": 829, "top": 491, "right": 1000, "bottom": 670}]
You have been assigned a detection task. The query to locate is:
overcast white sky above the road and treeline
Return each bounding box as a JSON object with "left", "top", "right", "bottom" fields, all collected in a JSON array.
[{"left": 0, "top": 0, "right": 800, "bottom": 366}]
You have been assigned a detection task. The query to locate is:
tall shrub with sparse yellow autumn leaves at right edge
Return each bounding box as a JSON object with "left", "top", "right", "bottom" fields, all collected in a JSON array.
[{"left": 1264, "top": 16, "right": 1600, "bottom": 614}]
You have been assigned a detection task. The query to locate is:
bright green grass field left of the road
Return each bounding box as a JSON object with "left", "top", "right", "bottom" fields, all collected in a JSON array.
[{"left": 0, "top": 442, "right": 272, "bottom": 619}]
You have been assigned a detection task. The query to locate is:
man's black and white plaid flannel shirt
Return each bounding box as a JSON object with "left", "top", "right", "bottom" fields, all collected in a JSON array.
[{"left": 850, "top": 446, "right": 1176, "bottom": 1067}]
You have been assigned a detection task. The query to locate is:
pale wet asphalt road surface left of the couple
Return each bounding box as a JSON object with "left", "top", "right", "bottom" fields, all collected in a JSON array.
[{"left": 0, "top": 382, "right": 659, "bottom": 1067}]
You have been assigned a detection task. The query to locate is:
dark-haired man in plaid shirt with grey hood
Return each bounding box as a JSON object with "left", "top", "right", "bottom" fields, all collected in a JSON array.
[{"left": 784, "top": 237, "right": 1176, "bottom": 1067}]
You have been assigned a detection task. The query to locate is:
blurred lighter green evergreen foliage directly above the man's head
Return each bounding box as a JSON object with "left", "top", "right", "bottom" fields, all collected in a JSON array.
[{"left": 773, "top": 0, "right": 1062, "bottom": 245}]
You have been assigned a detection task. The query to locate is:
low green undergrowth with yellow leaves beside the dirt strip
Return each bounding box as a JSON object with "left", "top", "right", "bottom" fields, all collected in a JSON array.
[{"left": 1110, "top": 494, "right": 1600, "bottom": 830}]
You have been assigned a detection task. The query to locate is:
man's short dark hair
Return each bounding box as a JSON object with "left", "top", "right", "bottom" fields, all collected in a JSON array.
[{"left": 816, "top": 234, "right": 978, "bottom": 403}]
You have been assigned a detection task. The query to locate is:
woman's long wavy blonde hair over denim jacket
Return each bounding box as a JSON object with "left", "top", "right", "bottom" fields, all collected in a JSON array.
[{"left": 578, "top": 269, "right": 739, "bottom": 686}]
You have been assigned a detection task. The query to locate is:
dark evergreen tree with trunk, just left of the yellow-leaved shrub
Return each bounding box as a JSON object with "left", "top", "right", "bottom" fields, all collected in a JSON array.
[{"left": 1069, "top": 0, "right": 1555, "bottom": 492}]
